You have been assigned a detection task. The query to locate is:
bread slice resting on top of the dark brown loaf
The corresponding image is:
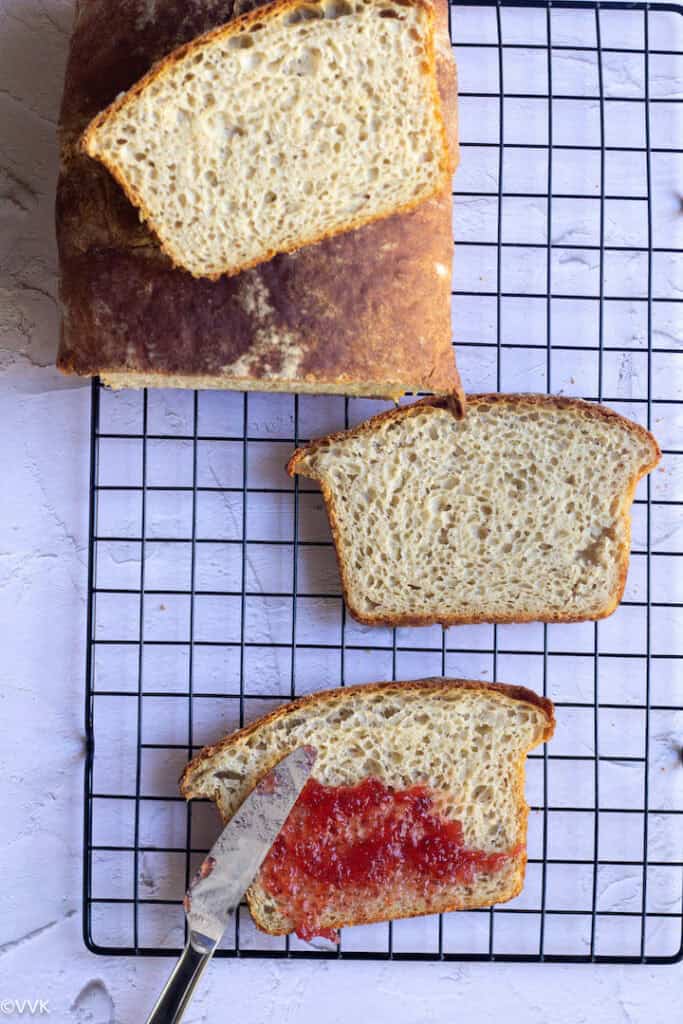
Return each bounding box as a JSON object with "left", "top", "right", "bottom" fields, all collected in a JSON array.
[{"left": 82, "top": 0, "right": 455, "bottom": 279}]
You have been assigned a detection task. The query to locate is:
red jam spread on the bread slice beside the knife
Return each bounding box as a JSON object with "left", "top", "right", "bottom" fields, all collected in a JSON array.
[{"left": 260, "top": 778, "right": 514, "bottom": 941}]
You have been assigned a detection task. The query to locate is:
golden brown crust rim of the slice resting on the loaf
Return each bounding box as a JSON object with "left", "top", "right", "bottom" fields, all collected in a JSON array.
[{"left": 79, "top": 0, "right": 455, "bottom": 281}]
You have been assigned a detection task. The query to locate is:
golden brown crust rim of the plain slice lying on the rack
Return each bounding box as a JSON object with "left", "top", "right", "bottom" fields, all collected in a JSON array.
[{"left": 287, "top": 392, "right": 661, "bottom": 628}]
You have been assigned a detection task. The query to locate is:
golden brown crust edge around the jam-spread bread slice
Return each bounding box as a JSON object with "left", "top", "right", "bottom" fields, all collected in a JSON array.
[{"left": 179, "top": 677, "right": 555, "bottom": 935}]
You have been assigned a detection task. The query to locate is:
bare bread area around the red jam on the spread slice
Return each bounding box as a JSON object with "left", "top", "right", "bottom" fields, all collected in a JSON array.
[{"left": 181, "top": 679, "right": 554, "bottom": 934}]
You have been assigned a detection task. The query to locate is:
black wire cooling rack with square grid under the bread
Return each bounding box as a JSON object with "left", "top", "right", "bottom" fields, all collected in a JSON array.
[{"left": 84, "top": 2, "right": 683, "bottom": 963}]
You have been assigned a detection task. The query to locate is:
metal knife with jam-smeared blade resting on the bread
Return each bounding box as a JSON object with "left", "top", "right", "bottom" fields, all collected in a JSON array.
[{"left": 147, "top": 746, "right": 316, "bottom": 1024}]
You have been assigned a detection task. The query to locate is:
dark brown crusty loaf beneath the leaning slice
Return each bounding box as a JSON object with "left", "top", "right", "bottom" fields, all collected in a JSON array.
[{"left": 56, "top": 0, "right": 462, "bottom": 404}]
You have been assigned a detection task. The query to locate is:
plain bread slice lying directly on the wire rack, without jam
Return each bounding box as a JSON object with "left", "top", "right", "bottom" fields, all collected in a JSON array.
[{"left": 288, "top": 394, "right": 660, "bottom": 626}]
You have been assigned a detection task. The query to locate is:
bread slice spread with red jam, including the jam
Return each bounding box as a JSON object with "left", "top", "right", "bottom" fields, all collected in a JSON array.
[{"left": 180, "top": 679, "right": 555, "bottom": 938}]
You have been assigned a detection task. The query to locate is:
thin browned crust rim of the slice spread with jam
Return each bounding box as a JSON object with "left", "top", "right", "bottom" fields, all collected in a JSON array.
[{"left": 180, "top": 678, "right": 555, "bottom": 935}]
